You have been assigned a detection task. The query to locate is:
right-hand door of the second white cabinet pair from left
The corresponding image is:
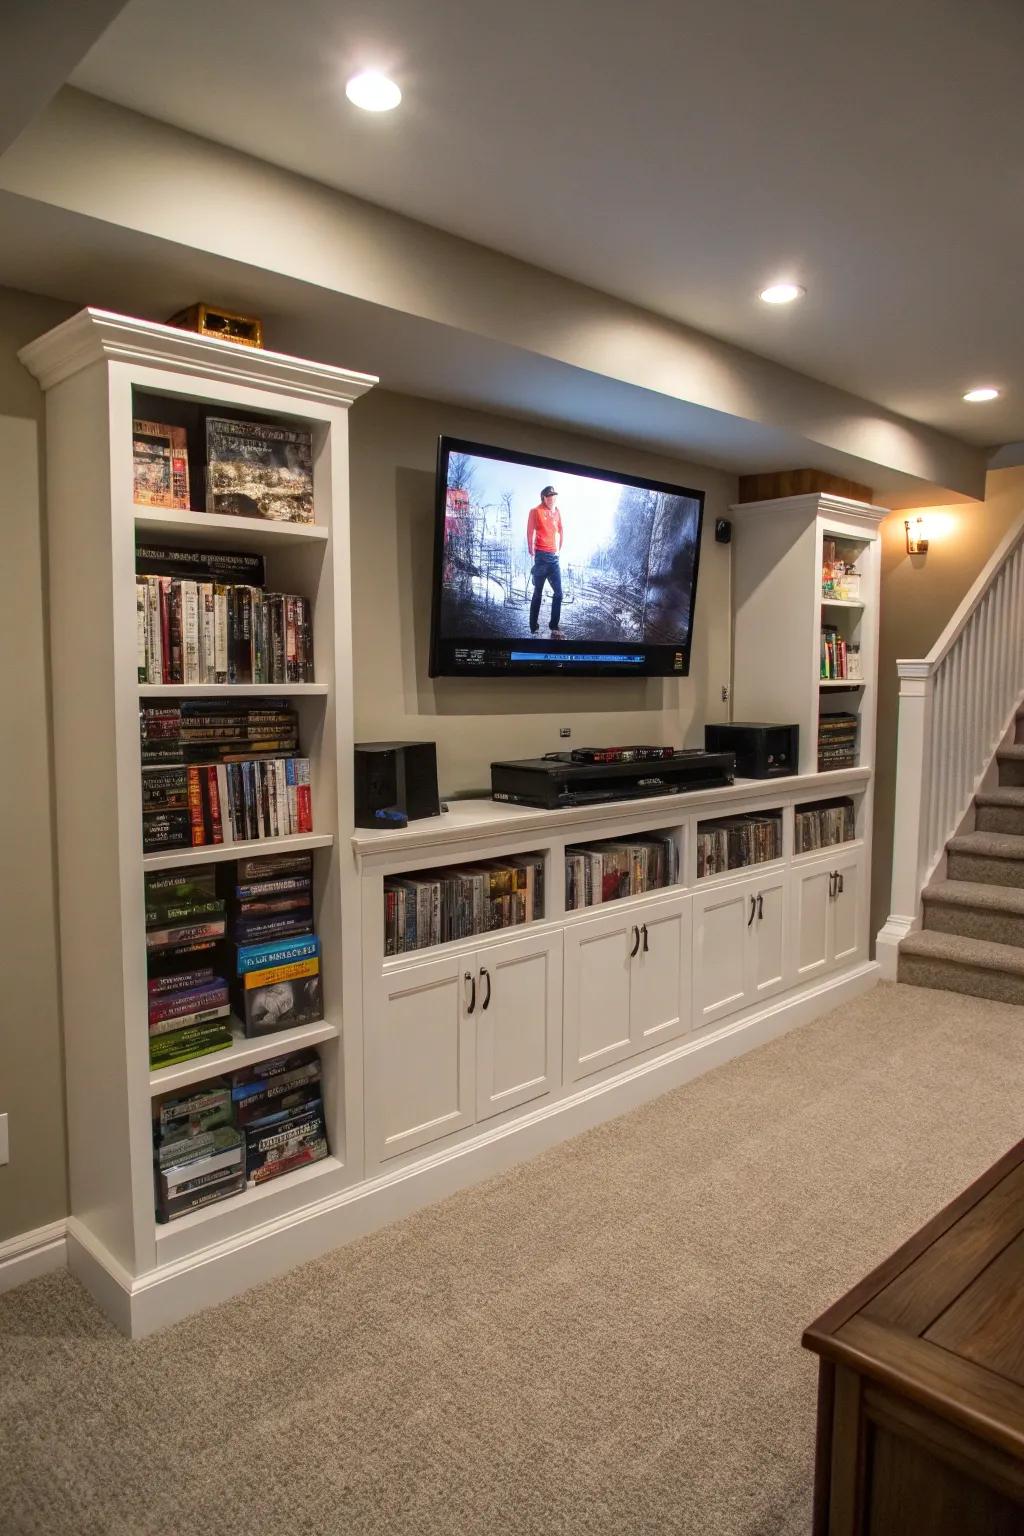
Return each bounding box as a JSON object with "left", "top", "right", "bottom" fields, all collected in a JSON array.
[{"left": 629, "top": 895, "right": 692, "bottom": 1051}]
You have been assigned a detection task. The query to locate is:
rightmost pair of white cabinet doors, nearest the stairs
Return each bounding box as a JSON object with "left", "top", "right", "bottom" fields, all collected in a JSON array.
[{"left": 791, "top": 848, "right": 866, "bottom": 982}]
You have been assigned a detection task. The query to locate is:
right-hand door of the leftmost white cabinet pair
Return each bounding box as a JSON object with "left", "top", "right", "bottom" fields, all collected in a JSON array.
[{"left": 476, "top": 934, "right": 562, "bottom": 1120}]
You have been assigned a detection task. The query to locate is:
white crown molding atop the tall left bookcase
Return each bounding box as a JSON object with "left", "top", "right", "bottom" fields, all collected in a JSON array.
[{"left": 18, "top": 309, "right": 378, "bottom": 407}]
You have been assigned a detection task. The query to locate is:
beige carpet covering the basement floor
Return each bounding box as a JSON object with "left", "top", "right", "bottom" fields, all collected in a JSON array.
[{"left": 0, "top": 986, "right": 1024, "bottom": 1536}]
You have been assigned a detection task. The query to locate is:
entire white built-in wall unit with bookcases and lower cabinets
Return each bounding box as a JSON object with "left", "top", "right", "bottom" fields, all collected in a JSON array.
[{"left": 21, "top": 310, "right": 883, "bottom": 1333}]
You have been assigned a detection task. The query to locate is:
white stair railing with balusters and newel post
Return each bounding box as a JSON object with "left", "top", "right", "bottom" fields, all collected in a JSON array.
[{"left": 877, "top": 515, "right": 1024, "bottom": 982}]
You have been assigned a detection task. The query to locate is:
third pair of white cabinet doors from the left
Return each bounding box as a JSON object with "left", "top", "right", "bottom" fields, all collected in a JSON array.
[{"left": 694, "top": 869, "right": 789, "bottom": 1028}]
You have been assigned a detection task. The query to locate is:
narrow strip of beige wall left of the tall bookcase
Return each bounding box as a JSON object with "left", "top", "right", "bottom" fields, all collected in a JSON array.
[{"left": 0, "top": 289, "right": 71, "bottom": 1241}]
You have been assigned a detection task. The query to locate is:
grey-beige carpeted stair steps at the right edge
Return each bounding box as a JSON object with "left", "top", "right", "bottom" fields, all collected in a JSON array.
[{"left": 897, "top": 713, "right": 1024, "bottom": 1005}]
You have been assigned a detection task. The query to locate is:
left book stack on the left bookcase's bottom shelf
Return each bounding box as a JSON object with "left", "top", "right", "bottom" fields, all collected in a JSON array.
[{"left": 154, "top": 1078, "right": 246, "bottom": 1221}]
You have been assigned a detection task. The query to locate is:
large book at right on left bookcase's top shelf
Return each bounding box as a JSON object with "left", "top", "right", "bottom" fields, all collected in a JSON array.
[{"left": 206, "top": 416, "right": 313, "bottom": 522}]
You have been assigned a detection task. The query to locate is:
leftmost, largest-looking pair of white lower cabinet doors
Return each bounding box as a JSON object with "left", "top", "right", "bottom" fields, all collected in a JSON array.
[{"left": 365, "top": 932, "right": 562, "bottom": 1161}]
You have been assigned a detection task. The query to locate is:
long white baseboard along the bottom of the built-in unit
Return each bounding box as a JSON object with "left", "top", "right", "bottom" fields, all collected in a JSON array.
[{"left": 68, "top": 960, "right": 880, "bottom": 1338}]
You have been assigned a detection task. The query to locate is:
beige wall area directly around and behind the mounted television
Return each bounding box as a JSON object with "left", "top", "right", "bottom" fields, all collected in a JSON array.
[{"left": 350, "top": 390, "right": 735, "bottom": 794}]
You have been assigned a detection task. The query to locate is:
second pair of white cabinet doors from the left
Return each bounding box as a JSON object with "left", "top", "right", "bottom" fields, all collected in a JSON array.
[{"left": 563, "top": 895, "right": 691, "bottom": 1083}]
